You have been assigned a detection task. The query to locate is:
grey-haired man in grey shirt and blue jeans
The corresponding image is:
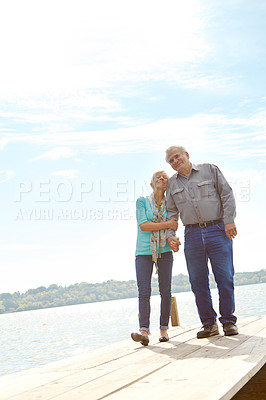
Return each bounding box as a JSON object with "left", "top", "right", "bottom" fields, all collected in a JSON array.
[{"left": 166, "top": 146, "right": 238, "bottom": 339}]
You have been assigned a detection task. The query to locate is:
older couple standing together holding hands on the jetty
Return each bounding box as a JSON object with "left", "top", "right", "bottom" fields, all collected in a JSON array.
[{"left": 131, "top": 146, "right": 238, "bottom": 346}]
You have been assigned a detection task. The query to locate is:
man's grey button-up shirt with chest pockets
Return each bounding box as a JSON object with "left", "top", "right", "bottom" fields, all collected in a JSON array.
[{"left": 166, "top": 164, "right": 236, "bottom": 237}]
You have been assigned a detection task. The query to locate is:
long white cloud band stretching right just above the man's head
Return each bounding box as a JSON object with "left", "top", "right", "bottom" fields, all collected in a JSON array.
[{"left": 6, "top": 114, "right": 260, "bottom": 160}]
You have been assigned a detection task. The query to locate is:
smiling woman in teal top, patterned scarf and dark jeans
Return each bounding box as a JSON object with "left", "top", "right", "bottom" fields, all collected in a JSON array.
[{"left": 131, "top": 171, "right": 177, "bottom": 346}]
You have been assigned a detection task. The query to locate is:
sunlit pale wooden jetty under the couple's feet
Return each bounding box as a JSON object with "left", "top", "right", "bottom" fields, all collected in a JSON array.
[{"left": 0, "top": 317, "right": 266, "bottom": 400}]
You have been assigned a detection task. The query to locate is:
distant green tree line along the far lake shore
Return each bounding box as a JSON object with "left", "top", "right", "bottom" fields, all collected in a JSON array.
[{"left": 0, "top": 269, "right": 266, "bottom": 314}]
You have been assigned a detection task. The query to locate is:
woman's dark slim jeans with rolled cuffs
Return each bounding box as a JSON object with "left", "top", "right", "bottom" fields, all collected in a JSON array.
[{"left": 136, "top": 251, "right": 173, "bottom": 332}]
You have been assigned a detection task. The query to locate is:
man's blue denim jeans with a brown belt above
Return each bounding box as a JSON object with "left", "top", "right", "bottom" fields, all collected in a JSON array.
[{"left": 185, "top": 222, "right": 236, "bottom": 326}]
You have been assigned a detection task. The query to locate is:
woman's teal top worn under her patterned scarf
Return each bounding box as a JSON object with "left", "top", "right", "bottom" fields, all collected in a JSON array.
[{"left": 136, "top": 197, "right": 171, "bottom": 256}]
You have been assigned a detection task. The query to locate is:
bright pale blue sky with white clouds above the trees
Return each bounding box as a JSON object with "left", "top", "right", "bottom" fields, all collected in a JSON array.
[{"left": 0, "top": 0, "right": 266, "bottom": 293}]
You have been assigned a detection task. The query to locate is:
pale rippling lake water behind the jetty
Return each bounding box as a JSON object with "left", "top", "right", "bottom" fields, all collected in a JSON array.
[{"left": 0, "top": 284, "right": 266, "bottom": 375}]
